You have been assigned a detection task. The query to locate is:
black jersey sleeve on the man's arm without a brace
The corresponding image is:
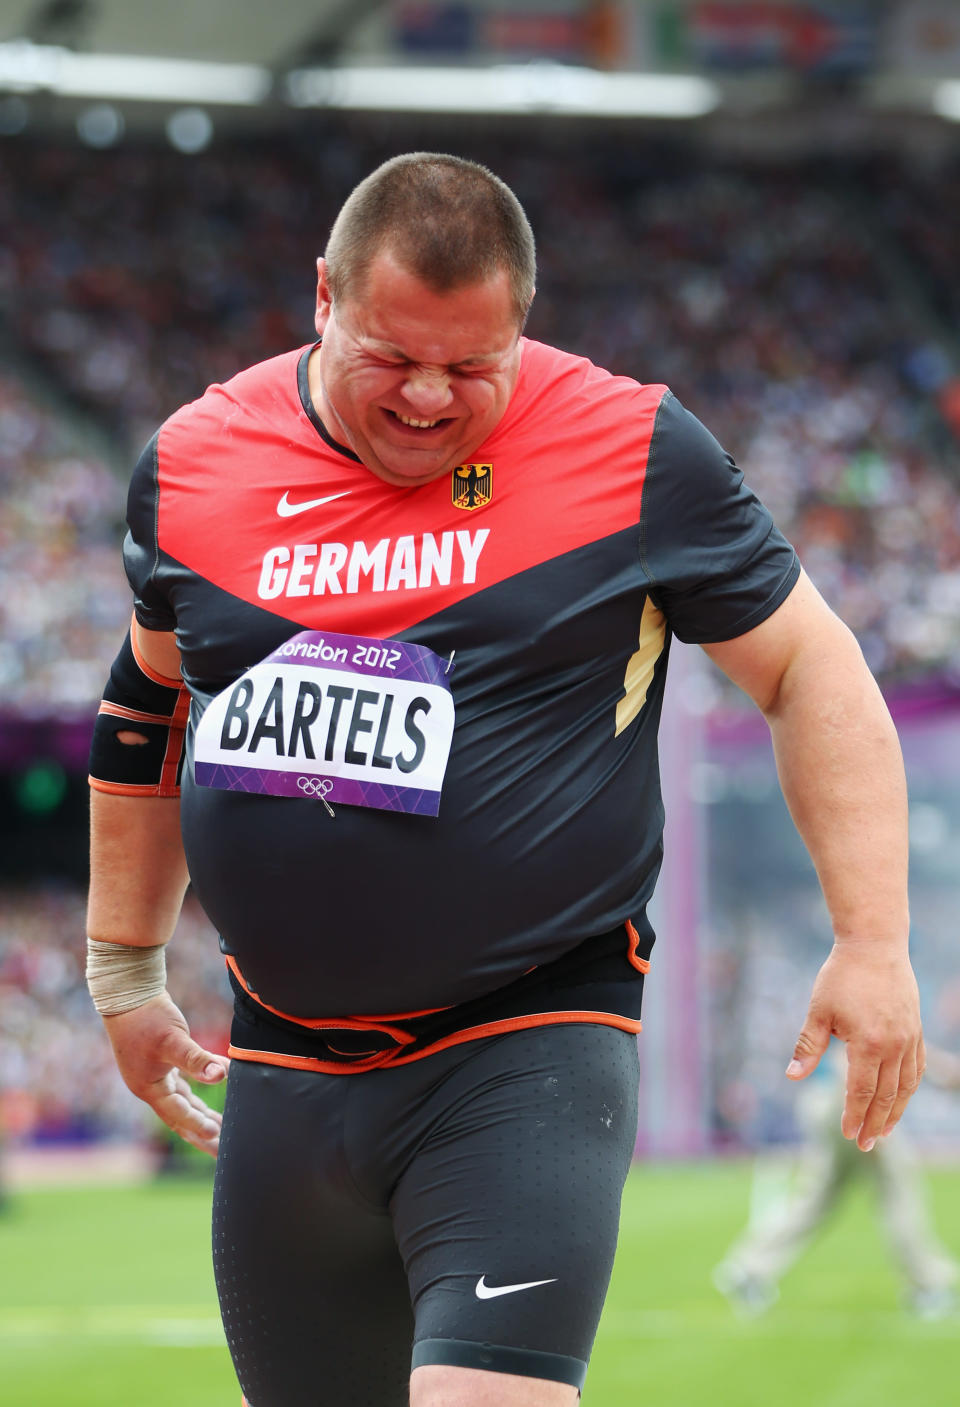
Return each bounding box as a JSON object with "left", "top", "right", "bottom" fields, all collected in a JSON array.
[{"left": 640, "top": 393, "right": 800, "bottom": 644}]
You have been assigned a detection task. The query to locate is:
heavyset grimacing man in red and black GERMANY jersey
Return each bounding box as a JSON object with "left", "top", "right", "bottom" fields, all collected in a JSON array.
[{"left": 90, "top": 153, "right": 923, "bottom": 1407}]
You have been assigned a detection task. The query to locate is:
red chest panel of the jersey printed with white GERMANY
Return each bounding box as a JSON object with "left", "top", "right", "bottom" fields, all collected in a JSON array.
[{"left": 158, "top": 342, "right": 664, "bottom": 637}]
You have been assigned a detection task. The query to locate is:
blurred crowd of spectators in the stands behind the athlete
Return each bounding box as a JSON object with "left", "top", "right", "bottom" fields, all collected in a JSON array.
[{"left": 0, "top": 121, "right": 960, "bottom": 1137}]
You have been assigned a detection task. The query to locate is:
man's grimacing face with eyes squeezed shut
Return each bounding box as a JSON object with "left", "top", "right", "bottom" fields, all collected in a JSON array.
[{"left": 310, "top": 249, "right": 521, "bottom": 487}]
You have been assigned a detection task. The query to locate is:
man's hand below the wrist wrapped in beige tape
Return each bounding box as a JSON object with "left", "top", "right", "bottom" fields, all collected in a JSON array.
[{"left": 103, "top": 992, "right": 229, "bottom": 1158}]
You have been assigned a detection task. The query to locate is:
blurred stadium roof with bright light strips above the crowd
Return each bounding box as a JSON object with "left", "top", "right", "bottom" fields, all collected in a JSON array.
[{"left": 0, "top": 0, "right": 960, "bottom": 134}]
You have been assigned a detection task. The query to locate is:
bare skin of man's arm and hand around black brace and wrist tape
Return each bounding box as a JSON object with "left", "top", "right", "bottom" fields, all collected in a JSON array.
[{"left": 87, "top": 625, "right": 227, "bottom": 1157}]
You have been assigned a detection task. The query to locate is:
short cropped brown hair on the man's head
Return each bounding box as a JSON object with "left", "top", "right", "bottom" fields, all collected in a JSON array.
[{"left": 319, "top": 152, "right": 536, "bottom": 326}]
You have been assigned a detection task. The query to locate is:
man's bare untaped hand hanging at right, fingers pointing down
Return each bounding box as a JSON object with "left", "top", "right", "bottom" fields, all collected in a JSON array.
[{"left": 787, "top": 940, "right": 926, "bottom": 1152}]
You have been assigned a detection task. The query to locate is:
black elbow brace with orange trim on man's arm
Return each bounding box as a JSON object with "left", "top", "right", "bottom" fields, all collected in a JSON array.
[{"left": 90, "top": 630, "right": 190, "bottom": 796}]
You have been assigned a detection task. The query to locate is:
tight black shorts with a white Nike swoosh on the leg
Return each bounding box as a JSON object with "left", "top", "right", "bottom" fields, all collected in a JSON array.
[{"left": 214, "top": 1023, "right": 638, "bottom": 1407}]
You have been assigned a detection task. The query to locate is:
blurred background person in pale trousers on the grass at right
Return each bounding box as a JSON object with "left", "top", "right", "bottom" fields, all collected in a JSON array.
[{"left": 714, "top": 1044, "right": 960, "bottom": 1320}]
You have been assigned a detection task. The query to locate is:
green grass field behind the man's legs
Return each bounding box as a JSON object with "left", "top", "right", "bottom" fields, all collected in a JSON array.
[{"left": 0, "top": 1164, "right": 960, "bottom": 1407}]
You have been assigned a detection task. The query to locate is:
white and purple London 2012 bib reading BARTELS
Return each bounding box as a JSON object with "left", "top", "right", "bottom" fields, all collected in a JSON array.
[{"left": 194, "top": 630, "right": 453, "bottom": 816}]
